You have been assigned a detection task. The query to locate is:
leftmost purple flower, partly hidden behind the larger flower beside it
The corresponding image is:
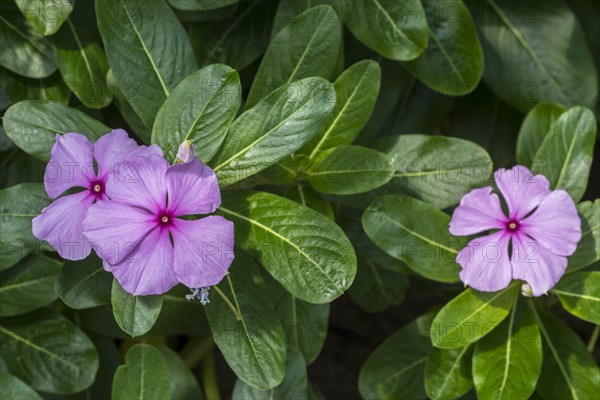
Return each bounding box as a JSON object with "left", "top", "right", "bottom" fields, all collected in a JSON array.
[{"left": 32, "top": 129, "right": 162, "bottom": 260}]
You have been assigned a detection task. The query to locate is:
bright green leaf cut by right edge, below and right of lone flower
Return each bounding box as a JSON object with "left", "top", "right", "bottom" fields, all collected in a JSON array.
[{"left": 551, "top": 271, "right": 600, "bottom": 325}]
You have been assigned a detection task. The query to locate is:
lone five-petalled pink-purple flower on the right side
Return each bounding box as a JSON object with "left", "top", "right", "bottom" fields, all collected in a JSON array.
[{"left": 450, "top": 166, "right": 581, "bottom": 296}]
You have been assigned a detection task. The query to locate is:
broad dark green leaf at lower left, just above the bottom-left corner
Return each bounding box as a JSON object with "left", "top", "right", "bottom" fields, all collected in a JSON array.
[{"left": 0, "top": 310, "right": 98, "bottom": 394}]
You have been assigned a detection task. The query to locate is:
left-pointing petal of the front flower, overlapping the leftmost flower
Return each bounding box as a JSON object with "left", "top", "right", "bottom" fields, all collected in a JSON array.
[{"left": 83, "top": 200, "right": 158, "bottom": 264}]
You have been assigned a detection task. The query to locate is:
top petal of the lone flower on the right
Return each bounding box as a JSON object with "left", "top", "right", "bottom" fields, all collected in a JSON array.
[{"left": 494, "top": 165, "right": 550, "bottom": 220}]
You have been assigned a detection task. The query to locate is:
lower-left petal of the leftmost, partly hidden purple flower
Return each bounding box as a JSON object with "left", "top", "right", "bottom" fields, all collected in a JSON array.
[{"left": 32, "top": 190, "right": 94, "bottom": 260}]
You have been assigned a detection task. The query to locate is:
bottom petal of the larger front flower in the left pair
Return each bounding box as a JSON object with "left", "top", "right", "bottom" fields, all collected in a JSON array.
[{"left": 112, "top": 227, "right": 178, "bottom": 296}]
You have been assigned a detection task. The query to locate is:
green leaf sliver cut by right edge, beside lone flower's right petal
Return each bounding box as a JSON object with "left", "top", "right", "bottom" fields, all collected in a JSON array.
[{"left": 567, "top": 199, "right": 600, "bottom": 273}]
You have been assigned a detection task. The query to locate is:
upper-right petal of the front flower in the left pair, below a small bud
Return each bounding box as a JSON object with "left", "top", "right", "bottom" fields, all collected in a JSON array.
[{"left": 167, "top": 158, "right": 221, "bottom": 216}]
